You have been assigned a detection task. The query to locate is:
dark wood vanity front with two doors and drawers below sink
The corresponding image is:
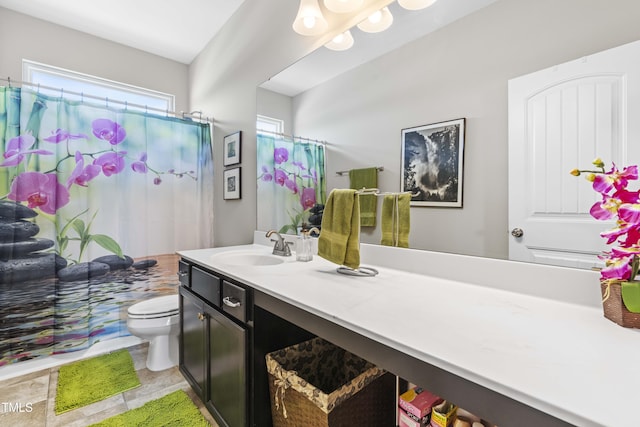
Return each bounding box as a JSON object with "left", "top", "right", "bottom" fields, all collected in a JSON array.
[{"left": 179, "top": 265, "right": 250, "bottom": 427}]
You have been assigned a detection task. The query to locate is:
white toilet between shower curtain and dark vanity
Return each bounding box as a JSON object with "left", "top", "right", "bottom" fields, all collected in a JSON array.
[{"left": 127, "top": 294, "right": 180, "bottom": 371}]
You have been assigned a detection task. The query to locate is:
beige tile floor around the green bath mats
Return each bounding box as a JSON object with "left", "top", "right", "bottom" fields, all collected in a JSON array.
[{"left": 0, "top": 343, "right": 217, "bottom": 427}]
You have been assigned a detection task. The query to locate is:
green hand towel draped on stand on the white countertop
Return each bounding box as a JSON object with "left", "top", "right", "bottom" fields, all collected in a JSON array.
[{"left": 318, "top": 189, "right": 360, "bottom": 269}]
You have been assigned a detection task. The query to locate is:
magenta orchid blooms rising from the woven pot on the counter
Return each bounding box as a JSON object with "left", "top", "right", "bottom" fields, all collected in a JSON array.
[{"left": 571, "top": 158, "right": 640, "bottom": 283}]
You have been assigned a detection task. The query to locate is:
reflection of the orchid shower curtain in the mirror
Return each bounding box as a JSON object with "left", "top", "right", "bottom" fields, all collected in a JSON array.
[{"left": 257, "top": 134, "right": 326, "bottom": 234}]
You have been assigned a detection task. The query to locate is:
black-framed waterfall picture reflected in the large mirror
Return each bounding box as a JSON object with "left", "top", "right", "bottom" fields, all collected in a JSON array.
[{"left": 400, "top": 118, "right": 465, "bottom": 208}]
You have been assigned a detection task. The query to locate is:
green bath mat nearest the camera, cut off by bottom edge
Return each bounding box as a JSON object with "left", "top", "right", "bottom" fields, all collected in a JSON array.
[{"left": 91, "top": 390, "right": 211, "bottom": 427}]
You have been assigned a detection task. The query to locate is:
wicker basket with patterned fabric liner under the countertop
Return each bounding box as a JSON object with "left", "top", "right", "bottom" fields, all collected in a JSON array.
[{"left": 266, "top": 338, "right": 396, "bottom": 427}]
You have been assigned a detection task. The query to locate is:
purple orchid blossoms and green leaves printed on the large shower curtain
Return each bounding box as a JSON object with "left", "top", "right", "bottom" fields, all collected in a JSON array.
[{"left": 0, "top": 118, "right": 197, "bottom": 262}]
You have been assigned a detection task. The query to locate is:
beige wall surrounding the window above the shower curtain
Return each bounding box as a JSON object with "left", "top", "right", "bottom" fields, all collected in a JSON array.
[{"left": 0, "top": 7, "right": 189, "bottom": 111}]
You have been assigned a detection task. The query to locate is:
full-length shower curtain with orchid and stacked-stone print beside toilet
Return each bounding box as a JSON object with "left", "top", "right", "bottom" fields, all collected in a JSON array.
[{"left": 0, "top": 87, "right": 213, "bottom": 366}]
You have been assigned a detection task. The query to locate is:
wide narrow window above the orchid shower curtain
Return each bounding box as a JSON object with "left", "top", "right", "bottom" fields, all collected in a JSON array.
[{"left": 22, "top": 60, "right": 175, "bottom": 112}]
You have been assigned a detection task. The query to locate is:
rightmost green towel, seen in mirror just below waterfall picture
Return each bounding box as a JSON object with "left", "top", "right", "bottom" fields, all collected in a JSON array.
[{"left": 380, "top": 194, "right": 411, "bottom": 248}]
